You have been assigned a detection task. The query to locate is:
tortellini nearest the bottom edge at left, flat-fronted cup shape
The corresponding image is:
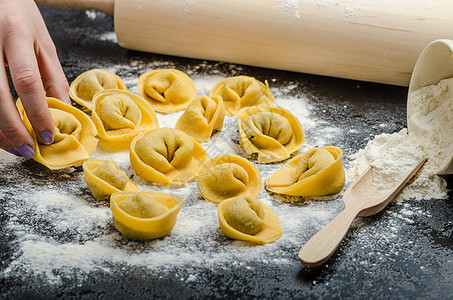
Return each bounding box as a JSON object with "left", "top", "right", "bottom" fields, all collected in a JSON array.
[{"left": 110, "top": 191, "right": 184, "bottom": 240}]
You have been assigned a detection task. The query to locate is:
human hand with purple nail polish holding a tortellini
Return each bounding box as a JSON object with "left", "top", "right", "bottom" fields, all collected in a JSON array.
[{"left": 0, "top": 0, "right": 70, "bottom": 158}]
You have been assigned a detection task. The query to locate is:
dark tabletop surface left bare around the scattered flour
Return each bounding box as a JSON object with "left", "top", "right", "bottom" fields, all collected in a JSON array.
[{"left": 0, "top": 7, "right": 453, "bottom": 299}]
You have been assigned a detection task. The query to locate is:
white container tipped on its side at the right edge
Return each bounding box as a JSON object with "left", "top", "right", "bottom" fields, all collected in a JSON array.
[{"left": 407, "top": 40, "right": 453, "bottom": 174}]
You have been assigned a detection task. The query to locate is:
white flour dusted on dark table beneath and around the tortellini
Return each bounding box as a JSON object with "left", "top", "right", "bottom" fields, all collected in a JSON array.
[{"left": 0, "top": 70, "right": 343, "bottom": 285}]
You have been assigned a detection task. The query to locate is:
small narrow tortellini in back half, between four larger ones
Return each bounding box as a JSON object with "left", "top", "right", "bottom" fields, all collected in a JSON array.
[{"left": 175, "top": 96, "right": 225, "bottom": 143}]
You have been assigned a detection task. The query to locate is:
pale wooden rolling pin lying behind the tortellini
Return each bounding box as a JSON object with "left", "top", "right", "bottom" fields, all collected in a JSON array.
[{"left": 36, "top": 0, "right": 453, "bottom": 86}]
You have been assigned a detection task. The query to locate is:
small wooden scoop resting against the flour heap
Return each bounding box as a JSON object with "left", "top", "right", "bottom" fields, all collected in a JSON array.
[{"left": 299, "top": 159, "right": 426, "bottom": 267}]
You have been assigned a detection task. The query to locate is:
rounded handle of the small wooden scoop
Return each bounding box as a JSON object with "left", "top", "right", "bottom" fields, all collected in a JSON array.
[{"left": 299, "top": 206, "right": 359, "bottom": 267}]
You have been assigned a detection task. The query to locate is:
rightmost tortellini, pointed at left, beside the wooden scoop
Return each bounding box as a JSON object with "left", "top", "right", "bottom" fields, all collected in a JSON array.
[{"left": 265, "top": 146, "right": 345, "bottom": 197}]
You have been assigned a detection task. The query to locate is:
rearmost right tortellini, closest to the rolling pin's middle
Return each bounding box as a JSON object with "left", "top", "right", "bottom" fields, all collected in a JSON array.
[{"left": 209, "top": 75, "right": 274, "bottom": 116}]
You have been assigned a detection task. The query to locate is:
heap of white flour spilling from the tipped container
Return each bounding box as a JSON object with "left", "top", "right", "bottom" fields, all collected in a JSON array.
[{"left": 348, "top": 78, "right": 453, "bottom": 200}]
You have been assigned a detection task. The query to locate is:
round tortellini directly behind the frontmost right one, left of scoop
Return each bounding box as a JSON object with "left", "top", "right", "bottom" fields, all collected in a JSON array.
[{"left": 197, "top": 155, "right": 261, "bottom": 204}]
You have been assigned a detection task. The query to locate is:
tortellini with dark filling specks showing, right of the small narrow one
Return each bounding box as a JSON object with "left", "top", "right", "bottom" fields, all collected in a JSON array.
[{"left": 238, "top": 106, "right": 305, "bottom": 163}]
